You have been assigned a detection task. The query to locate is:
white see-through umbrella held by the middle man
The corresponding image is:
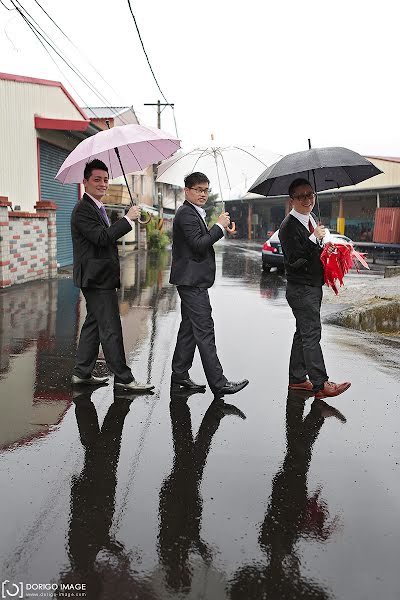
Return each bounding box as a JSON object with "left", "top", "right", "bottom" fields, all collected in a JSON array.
[{"left": 157, "top": 136, "right": 281, "bottom": 233}]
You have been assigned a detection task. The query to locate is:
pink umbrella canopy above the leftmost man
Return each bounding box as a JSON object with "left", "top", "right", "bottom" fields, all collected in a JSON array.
[{"left": 56, "top": 125, "right": 180, "bottom": 183}]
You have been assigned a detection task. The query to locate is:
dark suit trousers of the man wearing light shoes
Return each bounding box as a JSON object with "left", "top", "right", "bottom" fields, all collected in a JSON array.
[{"left": 74, "top": 288, "right": 134, "bottom": 383}]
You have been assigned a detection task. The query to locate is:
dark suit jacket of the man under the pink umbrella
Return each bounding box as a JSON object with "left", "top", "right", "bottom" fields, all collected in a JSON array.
[{"left": 71, "top": 194, "right": 131, "bottom": 290}]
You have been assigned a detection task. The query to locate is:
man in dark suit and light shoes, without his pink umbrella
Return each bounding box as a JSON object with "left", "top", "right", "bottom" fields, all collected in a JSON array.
[{"left": 71, "top": 160, "right": 154, "bottom": 392}]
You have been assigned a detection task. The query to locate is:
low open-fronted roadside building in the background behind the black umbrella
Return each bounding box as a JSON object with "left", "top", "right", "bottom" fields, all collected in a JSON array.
[{"left": 227, "top": 156, "right": 400, "bottom": 242}]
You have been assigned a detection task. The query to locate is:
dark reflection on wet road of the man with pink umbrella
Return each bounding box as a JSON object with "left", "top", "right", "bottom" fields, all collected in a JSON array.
[{"left": 62, "top": 390, "right": 155, "bottom": 600}]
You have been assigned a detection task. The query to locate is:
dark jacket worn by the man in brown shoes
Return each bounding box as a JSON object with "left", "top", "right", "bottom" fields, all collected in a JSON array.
[{"left": 279, "top": 214, "right": 324, "bottom": 287}]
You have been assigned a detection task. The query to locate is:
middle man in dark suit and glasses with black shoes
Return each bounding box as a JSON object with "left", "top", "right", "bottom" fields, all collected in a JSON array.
[{"left": 170, "top": 173, "right": 249, "bottom": 395}]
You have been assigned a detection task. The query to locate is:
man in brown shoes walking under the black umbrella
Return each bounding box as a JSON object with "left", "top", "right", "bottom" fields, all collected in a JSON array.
[{"left": 279, "top": 179, "right": 351, "bottom": 398}]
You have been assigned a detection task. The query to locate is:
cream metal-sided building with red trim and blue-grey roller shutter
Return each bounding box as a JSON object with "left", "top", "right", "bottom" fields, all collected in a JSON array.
[{"left": 0, "top": 73, "right": 99, "bottom": 266}]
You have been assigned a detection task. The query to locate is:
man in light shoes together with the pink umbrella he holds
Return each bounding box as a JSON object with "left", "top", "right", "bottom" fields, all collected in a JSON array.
[{"left": 56, "top": 125, "right": 180, "bottom": 392}]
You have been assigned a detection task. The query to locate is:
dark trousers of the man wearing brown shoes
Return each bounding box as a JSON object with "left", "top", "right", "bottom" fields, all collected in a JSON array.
[{"left": 286, "top": 282, "right": 328, "bottom": 390}]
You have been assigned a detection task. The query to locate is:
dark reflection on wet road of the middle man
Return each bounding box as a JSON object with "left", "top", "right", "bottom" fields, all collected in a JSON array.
[{"left": 158, "top": 391, "right": 246, "bottom": 592}]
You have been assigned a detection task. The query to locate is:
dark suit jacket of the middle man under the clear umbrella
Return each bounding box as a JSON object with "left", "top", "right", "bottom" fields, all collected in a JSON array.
[{"left": 169, "top": 200, "right": 224, "bottom": 288}]
